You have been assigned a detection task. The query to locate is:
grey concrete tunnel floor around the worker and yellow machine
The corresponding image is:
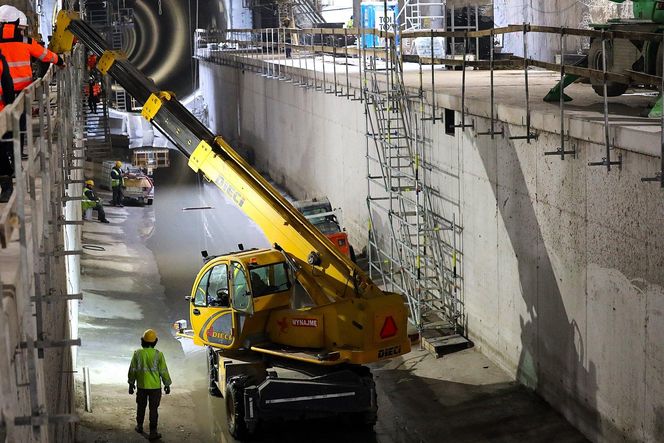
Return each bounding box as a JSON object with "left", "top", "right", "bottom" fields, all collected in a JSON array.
[{"left": 78, "top": 156, "right": 585, "bottom": 443}]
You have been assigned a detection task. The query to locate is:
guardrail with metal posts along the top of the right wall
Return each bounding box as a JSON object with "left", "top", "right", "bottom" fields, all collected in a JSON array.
[{"left": 195, "top": 23, "right": 664, "bottom": 183}]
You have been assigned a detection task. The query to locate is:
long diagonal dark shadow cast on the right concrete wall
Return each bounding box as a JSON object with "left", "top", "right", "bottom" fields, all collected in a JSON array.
[{"left": 474, "top": 126, "right": 600, "bottom": 437}]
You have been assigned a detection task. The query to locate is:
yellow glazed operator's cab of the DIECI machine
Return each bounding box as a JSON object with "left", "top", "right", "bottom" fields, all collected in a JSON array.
[{"left": 189, "top": 249, "right": 294, "bottom": 350}]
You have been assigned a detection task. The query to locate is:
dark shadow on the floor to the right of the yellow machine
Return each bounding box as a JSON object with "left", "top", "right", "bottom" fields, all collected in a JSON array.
[{"left": 374, "top": 362, "right": 586, "bottom": 443}]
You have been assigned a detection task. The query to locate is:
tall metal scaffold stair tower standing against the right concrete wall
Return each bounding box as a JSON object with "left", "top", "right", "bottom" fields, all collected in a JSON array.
[{"left": 362, "top": 23, "right": 463, "bottom": 346}]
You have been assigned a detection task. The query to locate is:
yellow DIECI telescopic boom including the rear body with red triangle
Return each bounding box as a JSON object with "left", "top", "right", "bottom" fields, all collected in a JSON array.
[{"left": 52, "top": 11, "right": 410, "bottom": 363}]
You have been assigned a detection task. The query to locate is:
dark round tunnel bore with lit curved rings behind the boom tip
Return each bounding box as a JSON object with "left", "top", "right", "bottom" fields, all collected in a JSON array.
[{"left": 123, "top": 0, "right": 226, "bottom": 97}]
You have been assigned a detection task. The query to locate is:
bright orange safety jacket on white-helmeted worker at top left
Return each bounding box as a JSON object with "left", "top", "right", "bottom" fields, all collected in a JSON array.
[{"left": 0, "top": 23, "right": 61, "bottom": 92}]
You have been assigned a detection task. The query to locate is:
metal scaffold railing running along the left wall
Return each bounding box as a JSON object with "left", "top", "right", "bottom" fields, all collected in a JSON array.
[{"left": 0, "top": 44, "right": 84, "bottom": 442}]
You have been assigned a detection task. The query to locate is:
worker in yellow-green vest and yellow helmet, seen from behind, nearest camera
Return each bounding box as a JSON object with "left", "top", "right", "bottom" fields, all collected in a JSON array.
[{"left": 127, "top": 329, "right": 171, "bottom": 440}]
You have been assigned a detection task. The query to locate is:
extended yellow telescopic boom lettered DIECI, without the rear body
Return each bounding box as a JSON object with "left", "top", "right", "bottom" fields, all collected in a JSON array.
[{"left": 51, "top": 11, "right": 410, "bottom": 364}]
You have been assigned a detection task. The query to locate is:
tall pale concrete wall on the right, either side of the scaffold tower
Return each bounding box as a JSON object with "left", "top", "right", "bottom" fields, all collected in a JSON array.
[{"left": 200, "top": 62, "right": 664, "bottom": 442}]
